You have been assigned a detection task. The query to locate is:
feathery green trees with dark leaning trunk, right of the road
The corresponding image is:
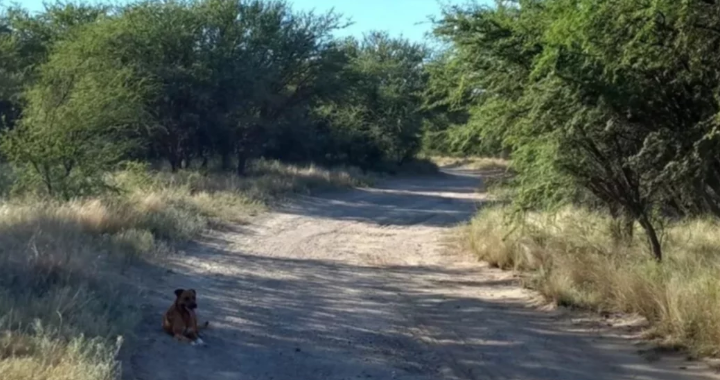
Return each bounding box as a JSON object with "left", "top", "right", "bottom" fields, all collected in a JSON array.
[{"left": 430, "top": 0, "right": 720, "bottom": 258}]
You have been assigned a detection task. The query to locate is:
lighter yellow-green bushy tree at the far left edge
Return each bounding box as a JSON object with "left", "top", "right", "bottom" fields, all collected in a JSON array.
[{"left": 2, "top": 15, "right": 146, "bottom": 198}]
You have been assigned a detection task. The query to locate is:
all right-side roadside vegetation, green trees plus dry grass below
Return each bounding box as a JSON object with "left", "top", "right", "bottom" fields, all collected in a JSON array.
[{"left": 424, "top": 0, "right": 720, "bottom": 355}]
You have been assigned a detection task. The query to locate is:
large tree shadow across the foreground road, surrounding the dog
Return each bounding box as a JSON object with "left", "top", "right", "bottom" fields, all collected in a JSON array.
[{"left": 122, "top": 240, "right": 703, "bottom": 380}]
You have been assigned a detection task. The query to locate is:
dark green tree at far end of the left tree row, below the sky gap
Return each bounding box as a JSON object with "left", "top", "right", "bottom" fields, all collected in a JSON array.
[{"left": 319, "top": 32, "right": 426, "bottom": 168}]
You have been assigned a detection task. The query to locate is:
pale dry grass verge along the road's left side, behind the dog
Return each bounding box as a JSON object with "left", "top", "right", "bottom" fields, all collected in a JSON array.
[{"left": 0, "top": 161, "right": 370, "bottom": 380}]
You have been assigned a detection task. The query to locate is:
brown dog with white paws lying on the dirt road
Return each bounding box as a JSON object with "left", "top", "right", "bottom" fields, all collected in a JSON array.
[{"left": 163, "top": 289, "right": 209, "bottom": 345}]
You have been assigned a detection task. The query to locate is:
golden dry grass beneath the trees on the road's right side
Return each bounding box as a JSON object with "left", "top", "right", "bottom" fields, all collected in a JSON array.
[{"left": 464, "top": 208, "right": 720, "bottom": 355}]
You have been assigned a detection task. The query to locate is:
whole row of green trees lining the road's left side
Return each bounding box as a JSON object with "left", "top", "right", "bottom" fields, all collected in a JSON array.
[{"left": 0, "top": 0, "right": 427, "bottom": 197}]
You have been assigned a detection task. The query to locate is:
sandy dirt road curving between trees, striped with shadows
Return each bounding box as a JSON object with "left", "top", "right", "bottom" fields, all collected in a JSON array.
[{"left": 123, "top": 171, "right": 715, "bottom": 380}]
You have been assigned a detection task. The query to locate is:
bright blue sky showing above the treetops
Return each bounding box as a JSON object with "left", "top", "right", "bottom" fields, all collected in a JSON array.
[{"left": 15, "top": 0, "right": 490, "bottom": 42}]
